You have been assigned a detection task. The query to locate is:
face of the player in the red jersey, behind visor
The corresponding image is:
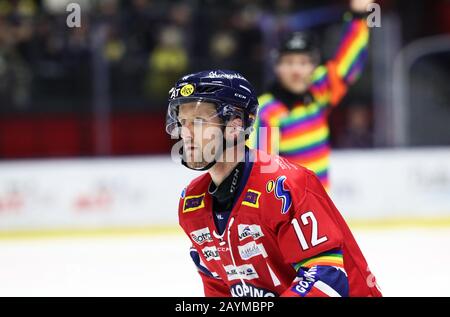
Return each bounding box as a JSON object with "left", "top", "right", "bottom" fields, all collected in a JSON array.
[{"left": 178, "top": 102, "right": 222, "bottom": 169}]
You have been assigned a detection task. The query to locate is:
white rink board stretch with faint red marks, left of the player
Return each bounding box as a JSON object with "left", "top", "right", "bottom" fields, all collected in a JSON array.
[{"left": 0, "top": 157, "right": 196, "bottom": 230}]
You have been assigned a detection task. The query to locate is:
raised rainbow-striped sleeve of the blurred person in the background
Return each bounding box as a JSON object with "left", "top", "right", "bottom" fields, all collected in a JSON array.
[{"left": 311, "top": 13, "right": 369, "bottom": 106}]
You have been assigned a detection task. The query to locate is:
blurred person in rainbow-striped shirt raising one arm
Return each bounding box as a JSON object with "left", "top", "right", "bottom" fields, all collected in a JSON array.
[{"left": 249, "top": 0, "right": 373, "bottom": 190}]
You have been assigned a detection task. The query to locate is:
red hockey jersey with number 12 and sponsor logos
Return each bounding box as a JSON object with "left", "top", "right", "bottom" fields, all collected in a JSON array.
[{"left": 179, "top": 151, "right": 381, "bottom": 297}]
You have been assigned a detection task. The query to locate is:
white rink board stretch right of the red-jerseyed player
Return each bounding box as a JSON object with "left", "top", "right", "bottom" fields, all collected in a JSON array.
[{"left": 330, "top": 148, "right": 450, "bottom": 219}]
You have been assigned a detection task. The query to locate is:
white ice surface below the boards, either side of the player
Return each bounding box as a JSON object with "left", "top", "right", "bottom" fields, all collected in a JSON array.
[{"left": 0, "top": 228, "right": 450, "bottom": 296}]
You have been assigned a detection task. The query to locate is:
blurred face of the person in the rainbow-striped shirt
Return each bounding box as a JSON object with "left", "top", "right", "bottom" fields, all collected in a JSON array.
[{"left": 275, "top": 53, "right": 316, "bottom": 94}]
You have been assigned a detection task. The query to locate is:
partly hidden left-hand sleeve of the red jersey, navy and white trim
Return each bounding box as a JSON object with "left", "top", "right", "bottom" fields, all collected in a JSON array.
[{"left": 190, "top": 246, "right": 231, "bottom": 297}]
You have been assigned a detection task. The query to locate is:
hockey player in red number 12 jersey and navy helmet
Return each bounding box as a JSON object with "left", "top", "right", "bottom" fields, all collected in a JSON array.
[{"left": 166, "top": 70, "right": 381, "bottom": 297}]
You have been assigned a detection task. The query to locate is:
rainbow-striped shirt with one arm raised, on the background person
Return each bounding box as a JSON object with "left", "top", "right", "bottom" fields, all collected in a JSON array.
[{"left": 249, "top": 19, "right": 369, "bottom": 188}]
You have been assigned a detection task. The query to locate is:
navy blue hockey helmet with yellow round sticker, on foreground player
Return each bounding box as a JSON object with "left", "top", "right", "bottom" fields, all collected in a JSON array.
[{"left": 166, "top": 70, "right": 258, "bottom": 136}]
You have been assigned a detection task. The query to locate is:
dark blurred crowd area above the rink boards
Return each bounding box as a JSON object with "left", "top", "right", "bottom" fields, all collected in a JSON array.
[{"left": 0, "top": 0, "right": 450, "bottom": 158}]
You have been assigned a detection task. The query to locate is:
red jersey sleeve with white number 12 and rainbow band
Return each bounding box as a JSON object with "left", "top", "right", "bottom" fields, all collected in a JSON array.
[{"left": 270, "top": 171, "right": 349, "bottom": 297}]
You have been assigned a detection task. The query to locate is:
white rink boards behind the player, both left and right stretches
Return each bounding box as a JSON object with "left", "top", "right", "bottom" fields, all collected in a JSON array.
[{"left": 0, "top": 149, "right": 450, "bottom": 231}]
